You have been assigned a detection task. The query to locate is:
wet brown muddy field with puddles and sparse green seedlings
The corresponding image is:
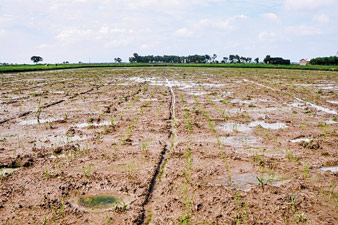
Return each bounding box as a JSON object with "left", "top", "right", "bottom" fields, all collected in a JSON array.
[{"left": 0, "top": 68, "right": 338, "bottom": 224}]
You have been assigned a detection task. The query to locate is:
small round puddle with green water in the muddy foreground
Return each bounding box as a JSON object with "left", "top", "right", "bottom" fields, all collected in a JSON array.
[{"left": 78, "top": 196, "right": 119, "bottom": 208}]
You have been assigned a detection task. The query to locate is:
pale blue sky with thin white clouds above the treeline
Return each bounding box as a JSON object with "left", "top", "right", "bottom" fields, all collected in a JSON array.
[{"left": 0, "top": 0, "right": 338, "bottom": 63}]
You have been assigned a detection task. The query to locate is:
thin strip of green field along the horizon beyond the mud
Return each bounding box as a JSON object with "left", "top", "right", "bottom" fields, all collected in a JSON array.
[{"left": 0, "top": 63, "right": 338, "bottom": 73}]
